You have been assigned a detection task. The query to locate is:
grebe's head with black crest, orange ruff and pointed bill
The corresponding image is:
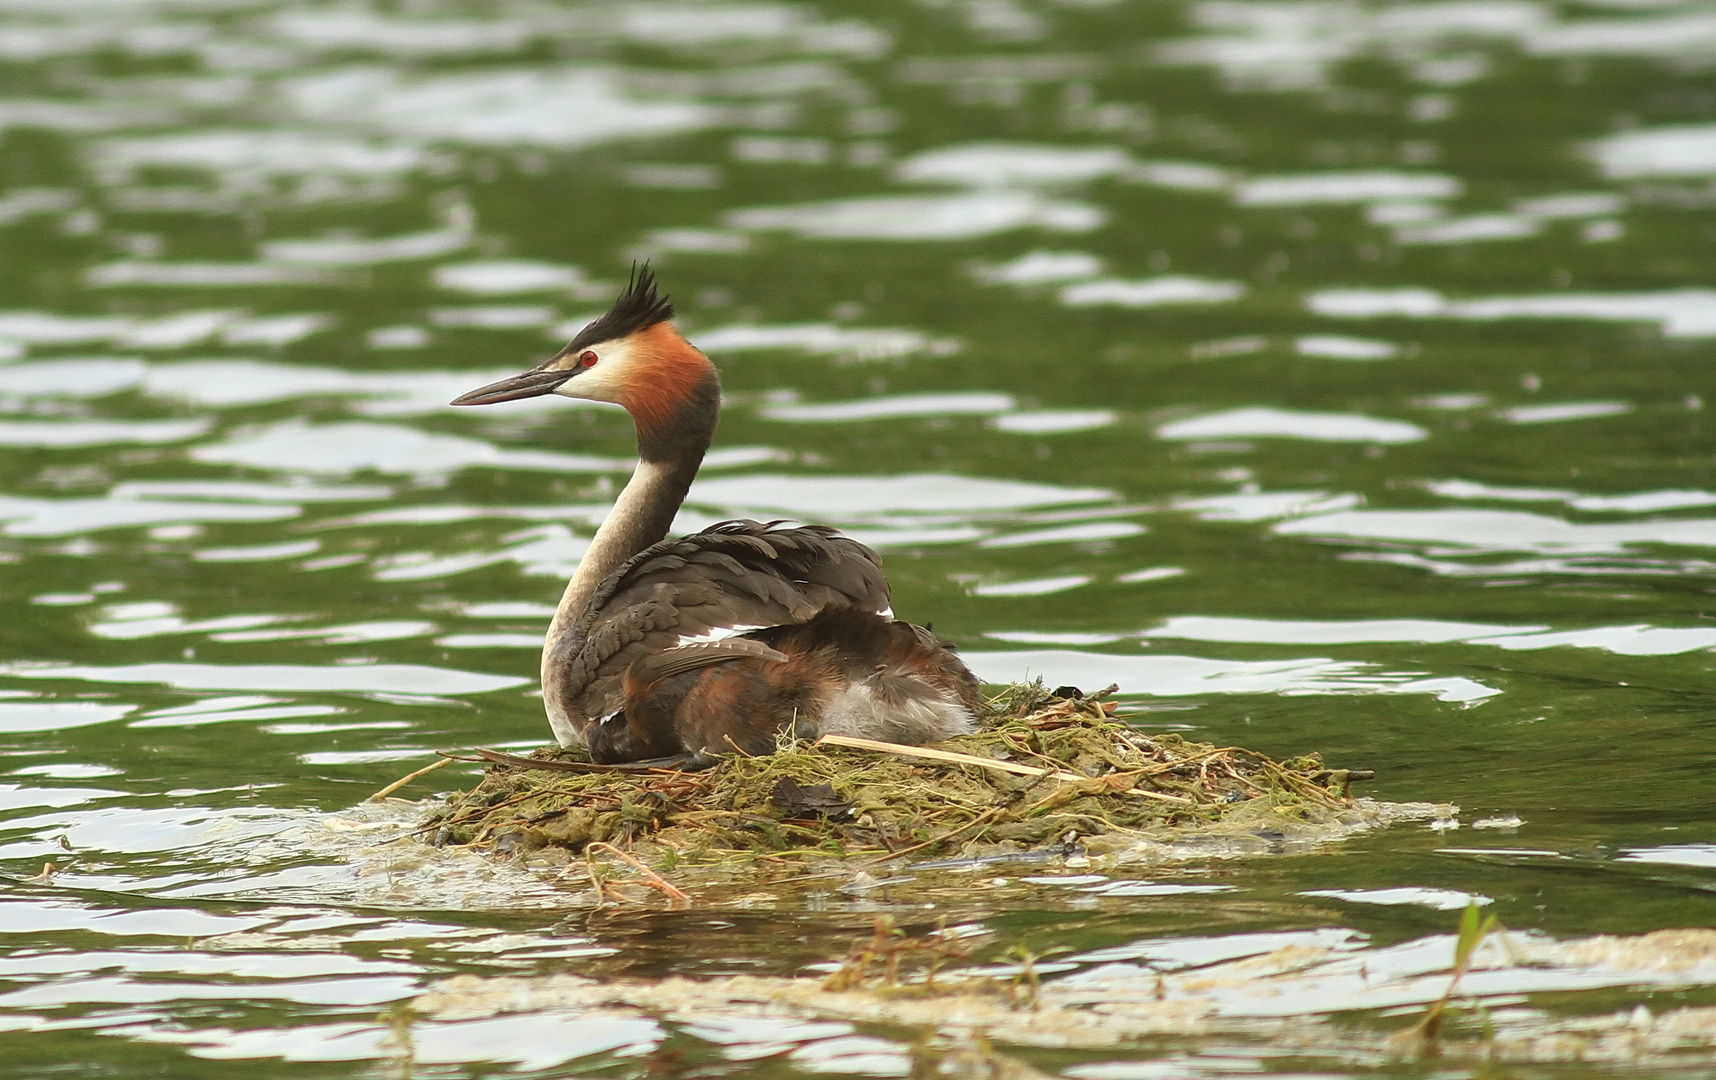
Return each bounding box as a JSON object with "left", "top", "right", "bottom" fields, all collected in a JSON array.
[{"left": 453, "top": 264, "right": 721, "bottom": 458}]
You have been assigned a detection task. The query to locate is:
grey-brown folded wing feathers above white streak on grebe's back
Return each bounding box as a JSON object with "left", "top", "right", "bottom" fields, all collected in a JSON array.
[{"left": 553, "top": 520, "right": 889, "bottom": 718}]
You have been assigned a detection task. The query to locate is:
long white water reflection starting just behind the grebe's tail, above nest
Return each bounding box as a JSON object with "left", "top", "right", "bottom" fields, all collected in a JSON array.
[{"left": 959, "top": 649, "right": 1500, "bottom": 702}]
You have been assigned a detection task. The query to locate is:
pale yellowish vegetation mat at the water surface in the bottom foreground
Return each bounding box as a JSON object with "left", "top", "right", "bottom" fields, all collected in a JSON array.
[{"left": 414, "top": 919, "right": 1716, "bottom": 1077}]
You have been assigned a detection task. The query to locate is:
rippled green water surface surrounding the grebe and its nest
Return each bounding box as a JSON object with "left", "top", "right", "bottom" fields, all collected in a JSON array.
[{"left": 0, "top": 0, "right": 1716, "bottom": 1077}]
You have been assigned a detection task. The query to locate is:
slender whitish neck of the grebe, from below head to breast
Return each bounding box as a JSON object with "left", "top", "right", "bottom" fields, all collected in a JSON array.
[{"left": 542, "top": 450, "right": 704, "bottom": 747}]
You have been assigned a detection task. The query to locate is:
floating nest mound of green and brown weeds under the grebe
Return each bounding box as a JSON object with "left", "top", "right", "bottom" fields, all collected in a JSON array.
[{"left": 419, "top": 683, "right": 1388, "bottom": 867}]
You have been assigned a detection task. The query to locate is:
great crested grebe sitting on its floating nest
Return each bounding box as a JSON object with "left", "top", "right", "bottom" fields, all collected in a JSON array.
[{"left": 453, "top": 266, "right": 982, "bottom": 768}]
